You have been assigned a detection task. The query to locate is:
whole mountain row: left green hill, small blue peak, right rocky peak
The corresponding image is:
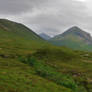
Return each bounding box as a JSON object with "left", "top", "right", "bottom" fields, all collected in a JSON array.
[{"left": 0, "top": 19, "right": 92, "bottom": 51}]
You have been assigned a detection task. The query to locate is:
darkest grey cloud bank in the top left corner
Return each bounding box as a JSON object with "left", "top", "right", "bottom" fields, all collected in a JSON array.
[{"left": 0, "top": 0, "right": 43, "bottom": 15}]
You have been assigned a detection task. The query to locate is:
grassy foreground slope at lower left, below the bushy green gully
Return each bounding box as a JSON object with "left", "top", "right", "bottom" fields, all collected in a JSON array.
[{"left": 0, "top": 58, "right": 72, "bottom": 92}]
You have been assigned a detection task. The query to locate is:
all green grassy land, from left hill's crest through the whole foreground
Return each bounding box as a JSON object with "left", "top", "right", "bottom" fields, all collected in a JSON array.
[{"left": 0, "top": 20, "right": 92, "bottom": 92}]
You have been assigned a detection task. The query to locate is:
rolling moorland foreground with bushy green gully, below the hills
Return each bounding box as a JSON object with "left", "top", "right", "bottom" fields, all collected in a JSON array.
[{"left": 0, "top": 46, "right": 92, "bottom": 92}]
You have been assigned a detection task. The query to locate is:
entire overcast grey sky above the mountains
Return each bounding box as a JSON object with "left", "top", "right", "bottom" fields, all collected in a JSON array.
[{"left": 0, "top": 0, "right": 92, "bottom": 36}]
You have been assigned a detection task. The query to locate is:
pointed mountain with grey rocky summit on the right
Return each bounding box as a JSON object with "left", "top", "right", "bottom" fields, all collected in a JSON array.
[{"left": 49, "top": 26, "right": 92, "bottom": 51}]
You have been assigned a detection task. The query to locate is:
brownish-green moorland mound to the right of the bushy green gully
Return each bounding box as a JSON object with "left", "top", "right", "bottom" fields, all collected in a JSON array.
[{"left": 29, "top": 47, "right": 92, "bottom": 92}]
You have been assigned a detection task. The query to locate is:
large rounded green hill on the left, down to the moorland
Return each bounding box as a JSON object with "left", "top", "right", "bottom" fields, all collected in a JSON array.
[{"left": 0, "top": 19, "right": 45, "bottom": 54}]
